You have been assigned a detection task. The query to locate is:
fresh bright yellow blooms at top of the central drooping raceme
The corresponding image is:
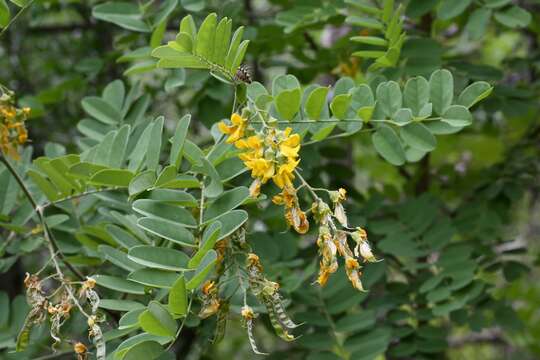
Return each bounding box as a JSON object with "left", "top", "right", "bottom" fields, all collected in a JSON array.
[{"left": 218, "top": 113, "right": 300, "bottom": 196}]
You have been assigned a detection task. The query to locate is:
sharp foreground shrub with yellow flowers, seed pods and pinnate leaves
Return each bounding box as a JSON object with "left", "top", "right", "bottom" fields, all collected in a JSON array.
[{"left": 1, "top": 9, "right": 491, "bottom": 359}]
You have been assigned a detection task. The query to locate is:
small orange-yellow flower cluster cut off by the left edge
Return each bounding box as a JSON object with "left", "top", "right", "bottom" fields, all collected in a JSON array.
[{"left": 0, "top": 92, "right": 30, "bottom": 158}]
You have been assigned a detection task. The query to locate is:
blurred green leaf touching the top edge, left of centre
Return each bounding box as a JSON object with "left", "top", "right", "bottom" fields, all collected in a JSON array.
[{"left": 92, "top": 1, "right": 150, "bottom": 32}]
